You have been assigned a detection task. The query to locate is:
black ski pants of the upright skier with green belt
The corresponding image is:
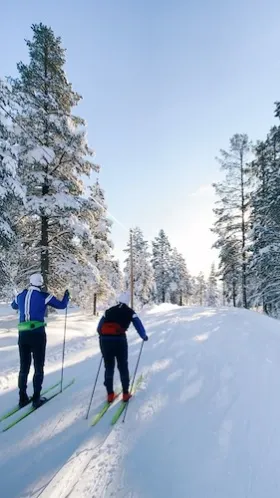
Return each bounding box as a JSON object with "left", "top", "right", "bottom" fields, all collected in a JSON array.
[{"left": 18, "top": 327, "right": 47, "bottom": 399}]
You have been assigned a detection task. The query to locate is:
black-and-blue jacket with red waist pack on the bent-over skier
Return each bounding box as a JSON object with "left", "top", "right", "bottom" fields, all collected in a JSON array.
[{"left": 97, "top": 303, "right": 146, "bottom": 339}]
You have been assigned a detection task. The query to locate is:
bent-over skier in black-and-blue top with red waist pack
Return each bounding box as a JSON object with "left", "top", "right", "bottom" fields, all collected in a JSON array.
[{"left": 97, "top": 293, "right": 148, "bottom": 403}]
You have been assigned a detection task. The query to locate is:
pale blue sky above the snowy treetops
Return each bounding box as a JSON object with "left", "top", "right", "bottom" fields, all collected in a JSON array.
[{"left": 0, "top": 0, "right": 280, "bottom": 274}]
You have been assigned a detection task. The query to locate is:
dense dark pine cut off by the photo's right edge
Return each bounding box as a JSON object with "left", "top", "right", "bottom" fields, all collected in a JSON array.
[{"left": 249, "top": 126, "right": 280, "bottom": 316}]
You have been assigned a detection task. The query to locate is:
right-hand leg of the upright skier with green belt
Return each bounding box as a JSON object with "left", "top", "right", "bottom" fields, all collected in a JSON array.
[{"left": 32, "top": 330, "right": 47, "bottom": 400}]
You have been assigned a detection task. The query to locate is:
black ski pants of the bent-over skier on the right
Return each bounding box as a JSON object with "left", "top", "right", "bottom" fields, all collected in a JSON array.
[{"left": 100, "top": 335, "right": 129, "bottom": 394}]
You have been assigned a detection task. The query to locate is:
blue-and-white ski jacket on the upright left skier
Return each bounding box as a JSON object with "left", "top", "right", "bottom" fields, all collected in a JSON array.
[{"left": 11, "top": 286, "right": 69, "bottom": 323}]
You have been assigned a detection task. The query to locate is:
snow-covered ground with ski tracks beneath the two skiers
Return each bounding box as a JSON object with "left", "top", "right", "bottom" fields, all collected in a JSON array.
[{"left": 0, "top": 305, "right": 280, "bottom": 498}]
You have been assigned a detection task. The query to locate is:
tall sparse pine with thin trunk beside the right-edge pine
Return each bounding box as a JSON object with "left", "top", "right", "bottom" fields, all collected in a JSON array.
[{"left": 212, "top": 134, "right": 251, "bottom": 308}]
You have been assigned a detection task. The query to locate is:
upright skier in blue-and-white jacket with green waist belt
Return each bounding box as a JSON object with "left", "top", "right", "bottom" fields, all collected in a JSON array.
[{"left": 12, "top": 273, "right": 69, "bottom": 408}]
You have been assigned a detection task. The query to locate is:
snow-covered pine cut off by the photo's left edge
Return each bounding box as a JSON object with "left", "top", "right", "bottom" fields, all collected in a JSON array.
[{"left": 0, "top": 80, "right": 25, "bottom": 296}]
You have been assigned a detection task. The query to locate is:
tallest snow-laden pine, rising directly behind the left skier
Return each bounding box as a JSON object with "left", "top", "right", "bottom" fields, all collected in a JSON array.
[{"left": 11, "top": 24, "right": 97, "bottom": 291}]
